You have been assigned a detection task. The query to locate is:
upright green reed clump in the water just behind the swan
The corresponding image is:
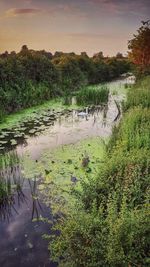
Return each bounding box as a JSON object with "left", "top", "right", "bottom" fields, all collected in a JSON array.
[{"left": 77, "top": 86, "right": 109, "bottom": 105}]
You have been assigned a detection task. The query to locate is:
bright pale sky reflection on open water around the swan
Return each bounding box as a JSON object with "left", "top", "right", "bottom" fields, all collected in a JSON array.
[{"left": 17, "top": 96, "right": 118, "bottom": 160}]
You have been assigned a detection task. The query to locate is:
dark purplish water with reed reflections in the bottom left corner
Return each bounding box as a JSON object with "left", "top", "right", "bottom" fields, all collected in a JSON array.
[{"left": 0, "top": 152, "right": 57, "bottom": 267}]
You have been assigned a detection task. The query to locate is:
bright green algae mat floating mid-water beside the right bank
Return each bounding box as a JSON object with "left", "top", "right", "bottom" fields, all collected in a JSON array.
[{"left": 34, "top": 137, "right": 105, "bottom": 216}]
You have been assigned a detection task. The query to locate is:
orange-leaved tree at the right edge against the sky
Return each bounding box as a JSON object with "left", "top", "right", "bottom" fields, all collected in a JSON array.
[{"left": 128, "top": 20, "right": 150, "bottom": 72}]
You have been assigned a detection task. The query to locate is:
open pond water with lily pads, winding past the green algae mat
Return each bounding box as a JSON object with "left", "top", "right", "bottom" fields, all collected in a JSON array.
[{"left": 0, "top": 77, "right": 134, "bottom": 267}]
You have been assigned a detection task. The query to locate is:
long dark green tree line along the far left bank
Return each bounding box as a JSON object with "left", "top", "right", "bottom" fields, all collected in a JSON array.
[{"left": 0, "top": 45, "right": 130, "bottom": 119}]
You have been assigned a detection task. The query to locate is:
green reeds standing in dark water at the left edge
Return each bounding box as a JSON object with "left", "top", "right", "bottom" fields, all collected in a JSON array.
[{"left": 0, "top": 152, "right": 24, "bottom": 221}]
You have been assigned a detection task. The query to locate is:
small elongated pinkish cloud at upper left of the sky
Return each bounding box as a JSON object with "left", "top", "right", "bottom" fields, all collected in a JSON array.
[{"left": 5, "top": 8, "right": 42, "bottom": 17}]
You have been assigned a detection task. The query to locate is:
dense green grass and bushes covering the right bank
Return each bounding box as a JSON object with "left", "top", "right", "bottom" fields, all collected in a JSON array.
[{"left": 50, "top": 77, "right": 150, "bottom": 267}]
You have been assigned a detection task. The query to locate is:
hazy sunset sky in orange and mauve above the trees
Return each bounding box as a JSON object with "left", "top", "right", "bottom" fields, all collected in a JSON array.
[{"left": 0, "top": 0, "right": 150, "bottom": 56}]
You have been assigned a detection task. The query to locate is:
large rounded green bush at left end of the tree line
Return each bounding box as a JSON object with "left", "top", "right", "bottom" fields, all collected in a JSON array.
[{"left": 0, "top": 52, "right": 58, "bottom": 113}]
